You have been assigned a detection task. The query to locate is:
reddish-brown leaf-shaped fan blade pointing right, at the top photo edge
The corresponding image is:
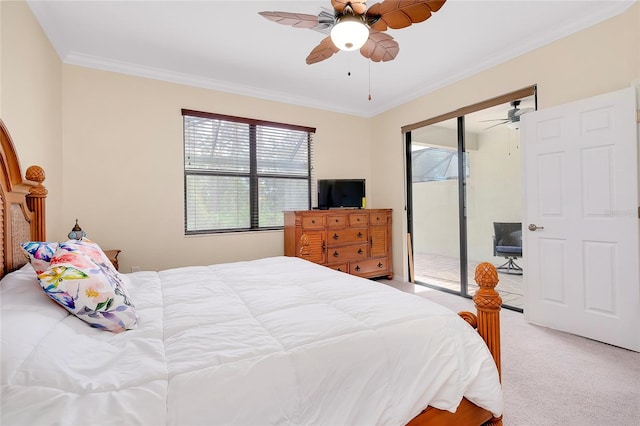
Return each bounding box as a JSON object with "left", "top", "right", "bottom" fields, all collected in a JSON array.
[{"left": 367, "top": 0, "right": 446, "bottom": 31}]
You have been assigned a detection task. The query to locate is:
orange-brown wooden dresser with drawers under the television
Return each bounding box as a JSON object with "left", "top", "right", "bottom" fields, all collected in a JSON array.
[{"left": 284, "top": 209, "right": 393, "bottom": 279}]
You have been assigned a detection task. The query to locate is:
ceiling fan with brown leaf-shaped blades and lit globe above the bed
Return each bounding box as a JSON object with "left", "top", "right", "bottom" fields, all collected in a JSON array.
[{"left": 259, "top": 0, "right": 446, "bottom": 65}]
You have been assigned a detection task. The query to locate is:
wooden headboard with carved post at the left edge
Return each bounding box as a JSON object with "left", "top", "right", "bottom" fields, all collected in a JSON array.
[{"left": 0, "top": 120, "right": 47, "bottom": 277}]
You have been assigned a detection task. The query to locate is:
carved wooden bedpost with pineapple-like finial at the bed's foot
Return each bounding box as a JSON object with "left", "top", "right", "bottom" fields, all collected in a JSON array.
[{"left": 473, "top": 262, "right": 502, "bottom": 426}]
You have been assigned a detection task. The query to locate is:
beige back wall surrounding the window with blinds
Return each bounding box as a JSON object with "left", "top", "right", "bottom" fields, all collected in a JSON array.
[{"left": 63, "top": 65, "right": 375, "bottom": 271}]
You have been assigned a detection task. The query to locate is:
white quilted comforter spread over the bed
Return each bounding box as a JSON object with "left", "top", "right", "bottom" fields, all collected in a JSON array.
[{"left": 0, "top": 257, "right": 502, "bottom": 425}]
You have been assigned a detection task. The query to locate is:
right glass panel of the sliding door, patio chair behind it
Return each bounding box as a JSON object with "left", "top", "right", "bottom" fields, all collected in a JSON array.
[{"left": 465, "top": 96, "right": 535, "bottom": 310}]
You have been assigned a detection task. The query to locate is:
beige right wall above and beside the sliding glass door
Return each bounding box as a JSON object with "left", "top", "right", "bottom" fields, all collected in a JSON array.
[{"left": 371, "top": 3, "right": 640, "bottom": 278}]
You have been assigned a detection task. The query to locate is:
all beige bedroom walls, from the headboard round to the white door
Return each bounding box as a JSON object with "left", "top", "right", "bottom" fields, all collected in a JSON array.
[{"left": 0, "top": 2, "right": 640, "bottom": 277}]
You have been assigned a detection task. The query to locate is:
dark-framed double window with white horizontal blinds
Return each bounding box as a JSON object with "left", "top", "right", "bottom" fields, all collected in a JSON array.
[{"left": 182, "top": 110, "right": 315, "bottom": 234}]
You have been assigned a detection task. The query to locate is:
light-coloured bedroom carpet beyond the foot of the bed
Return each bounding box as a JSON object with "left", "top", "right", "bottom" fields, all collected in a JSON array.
[{"left": 382, "top": 280, "right": 640, "bottom": 426}]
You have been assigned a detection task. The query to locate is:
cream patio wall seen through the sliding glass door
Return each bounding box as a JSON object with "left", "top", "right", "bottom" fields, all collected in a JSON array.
[{"left": 412, "top": 124, "right": 522, "bottom": 262}]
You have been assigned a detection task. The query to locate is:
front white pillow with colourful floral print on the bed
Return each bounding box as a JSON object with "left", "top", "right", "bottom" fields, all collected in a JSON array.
[{"left": 38, "top": 240, "right": 138, "bottom": 333}]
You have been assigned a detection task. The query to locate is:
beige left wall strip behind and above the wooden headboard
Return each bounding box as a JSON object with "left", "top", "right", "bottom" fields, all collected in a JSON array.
[{"left": 0, "top": 1, "right": 63, "bottom": 237}]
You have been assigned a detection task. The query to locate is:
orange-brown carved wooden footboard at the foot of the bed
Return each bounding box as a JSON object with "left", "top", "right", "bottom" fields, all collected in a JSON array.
[{"left": 408, "top": 262, "right": 502, "bottom": 426}]
